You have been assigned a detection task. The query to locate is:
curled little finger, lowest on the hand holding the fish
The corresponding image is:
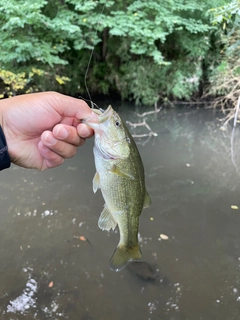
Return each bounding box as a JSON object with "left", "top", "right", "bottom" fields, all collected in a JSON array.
[{"left": 38, "top": 141, "right": 64, "bottom": 170}]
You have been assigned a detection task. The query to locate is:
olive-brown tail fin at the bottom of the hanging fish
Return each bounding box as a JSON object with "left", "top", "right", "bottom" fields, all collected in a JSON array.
[{"left": 109, "top": 244, "right": 142, "bottom": 272}]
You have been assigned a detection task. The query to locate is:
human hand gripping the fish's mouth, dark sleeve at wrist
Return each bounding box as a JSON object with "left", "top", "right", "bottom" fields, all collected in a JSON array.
[{"left": 0, "top": 92, "right": 93, "bottom": 170}]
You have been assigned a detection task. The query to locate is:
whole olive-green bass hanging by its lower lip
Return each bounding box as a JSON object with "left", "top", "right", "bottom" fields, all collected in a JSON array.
[{"left": 83, "top": 105, "right": 151, "bottom": 272}]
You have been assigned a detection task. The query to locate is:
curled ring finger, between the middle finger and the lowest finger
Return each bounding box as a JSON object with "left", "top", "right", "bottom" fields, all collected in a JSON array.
[{"left": 41, "top": 131, "right": 79, "bottom": 158}]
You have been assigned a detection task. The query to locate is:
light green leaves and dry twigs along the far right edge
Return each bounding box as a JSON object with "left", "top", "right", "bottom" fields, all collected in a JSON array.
[{"left": 208, "top": 0, "right": 240, "bottom": 109}]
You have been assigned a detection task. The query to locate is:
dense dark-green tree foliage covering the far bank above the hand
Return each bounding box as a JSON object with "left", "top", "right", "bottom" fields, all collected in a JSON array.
[{"left": 0, "top": 0, "right": 232, "bottom": 104}]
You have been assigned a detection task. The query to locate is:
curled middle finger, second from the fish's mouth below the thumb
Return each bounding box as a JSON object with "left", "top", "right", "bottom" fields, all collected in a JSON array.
[{"left": 52, "top": 124, "right": 84, "bottom": 147}]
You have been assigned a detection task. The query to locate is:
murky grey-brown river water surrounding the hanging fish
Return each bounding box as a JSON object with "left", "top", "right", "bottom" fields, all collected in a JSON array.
[{"left": 0, "top": 105, "right": 240, "bottom": 320}]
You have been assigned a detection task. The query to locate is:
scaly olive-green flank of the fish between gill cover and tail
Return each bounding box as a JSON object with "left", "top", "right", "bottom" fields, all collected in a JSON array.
[{"left": 94, "top": 122, "right": 145, "bottom": 247}]
